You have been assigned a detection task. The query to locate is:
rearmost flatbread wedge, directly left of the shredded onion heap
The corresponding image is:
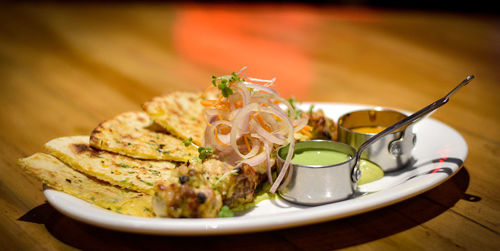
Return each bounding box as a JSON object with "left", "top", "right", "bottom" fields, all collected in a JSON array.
[{"left": 142, "top": 92, "right": 216, "bottom": 145}]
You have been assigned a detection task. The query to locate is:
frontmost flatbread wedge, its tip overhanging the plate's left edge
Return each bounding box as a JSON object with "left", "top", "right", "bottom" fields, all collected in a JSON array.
[{"left": 18, "top": 153, "right": 153, "bottom": 217}]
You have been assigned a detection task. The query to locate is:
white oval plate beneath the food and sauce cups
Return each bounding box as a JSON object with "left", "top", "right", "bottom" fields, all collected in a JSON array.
[{"left": 44, "top": 103, "right": 468, "bottom": 235}]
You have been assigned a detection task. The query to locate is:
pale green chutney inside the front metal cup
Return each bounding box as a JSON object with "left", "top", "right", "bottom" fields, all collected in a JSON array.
[{"left": 290, "top": 148, "right": 351, "bottom": 166}]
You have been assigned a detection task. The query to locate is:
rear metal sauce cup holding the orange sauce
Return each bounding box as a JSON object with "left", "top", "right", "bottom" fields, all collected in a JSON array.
[{"left": 338, "top": 108, "right": 416, "bottom": 172}]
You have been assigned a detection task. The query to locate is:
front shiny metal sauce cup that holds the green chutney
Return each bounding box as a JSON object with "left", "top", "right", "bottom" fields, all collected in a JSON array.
[{"left": 277, "top": 140, "right": 360, "bottom": 205}]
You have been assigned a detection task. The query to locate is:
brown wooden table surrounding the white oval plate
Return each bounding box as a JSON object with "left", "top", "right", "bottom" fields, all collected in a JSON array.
[{"left": 0, "top": 4, "right": 500, "bottom": 250}]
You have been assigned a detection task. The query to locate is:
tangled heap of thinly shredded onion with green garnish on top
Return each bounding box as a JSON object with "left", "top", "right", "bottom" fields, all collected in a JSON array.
[{"left": 203, "top": 67, "right": 307, "bottom": 193}]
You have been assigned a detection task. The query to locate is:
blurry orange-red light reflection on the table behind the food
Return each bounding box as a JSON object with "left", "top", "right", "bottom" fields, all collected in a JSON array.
[{"left": 173, "top": 5, "right": 377, "bottom": 100}]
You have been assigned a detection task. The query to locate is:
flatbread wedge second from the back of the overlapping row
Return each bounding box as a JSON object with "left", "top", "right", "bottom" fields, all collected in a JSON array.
[{"left": 90, "top": 112, "right": 198, "bottom": 162}]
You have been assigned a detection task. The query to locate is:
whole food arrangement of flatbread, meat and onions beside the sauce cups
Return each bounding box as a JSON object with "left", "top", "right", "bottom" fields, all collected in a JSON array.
[{"left": 19, "top": 68, "right": 336, "bottom": 218}]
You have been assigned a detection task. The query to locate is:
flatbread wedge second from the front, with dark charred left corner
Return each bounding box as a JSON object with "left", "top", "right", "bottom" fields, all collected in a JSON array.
[{"left": 45, "top": 136, "right": 177, "bottom": 194}]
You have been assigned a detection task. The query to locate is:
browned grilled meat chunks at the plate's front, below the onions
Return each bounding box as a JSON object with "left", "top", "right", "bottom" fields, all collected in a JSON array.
[{"left": 153, "top": 159, "right": 263, "bottom": 217}]
